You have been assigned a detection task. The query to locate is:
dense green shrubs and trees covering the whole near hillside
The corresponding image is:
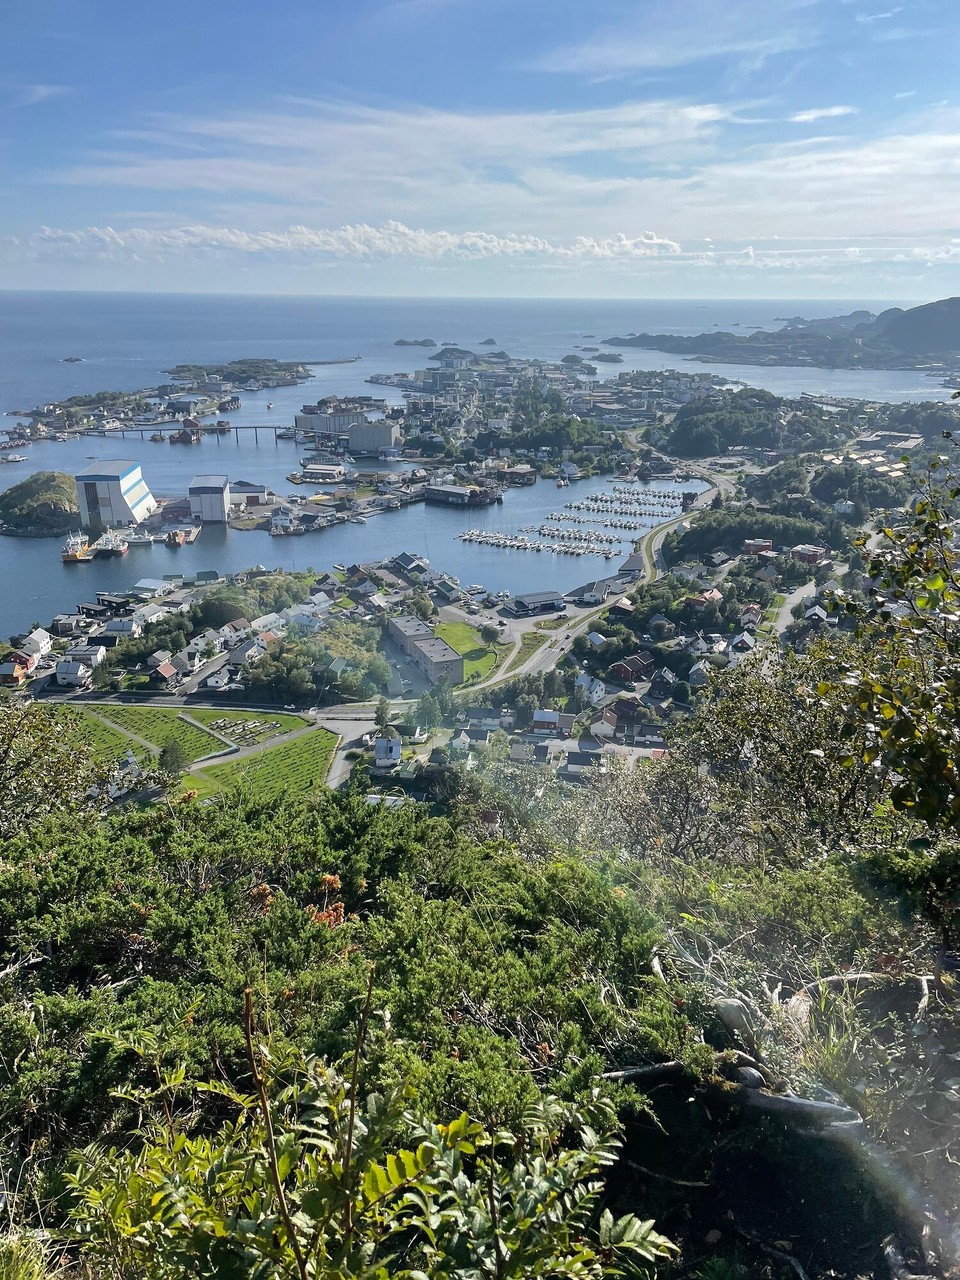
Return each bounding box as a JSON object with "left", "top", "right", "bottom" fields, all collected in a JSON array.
[{"left": 0, "top": 473, "right": 960, "bottom": 1280}]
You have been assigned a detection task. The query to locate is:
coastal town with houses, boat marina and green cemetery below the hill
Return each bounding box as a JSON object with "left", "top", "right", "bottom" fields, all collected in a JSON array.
[{"left": 0, "top": 325, "right": 955, "bottom": 797}]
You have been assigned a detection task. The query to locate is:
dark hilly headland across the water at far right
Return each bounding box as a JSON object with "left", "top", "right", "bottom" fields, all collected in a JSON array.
[{"left": 598, "top": 298, "right": 960, "bottom": 369}]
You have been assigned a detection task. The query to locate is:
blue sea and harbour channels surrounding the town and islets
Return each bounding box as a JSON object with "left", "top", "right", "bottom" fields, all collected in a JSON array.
[{"left": 0, "top": 292, "right": 950, "bottom": 635}]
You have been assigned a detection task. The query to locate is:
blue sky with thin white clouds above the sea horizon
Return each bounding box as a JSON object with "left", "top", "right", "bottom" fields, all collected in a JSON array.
[{"left": 0, "top": 0, "right": 960, "bottom": 300}]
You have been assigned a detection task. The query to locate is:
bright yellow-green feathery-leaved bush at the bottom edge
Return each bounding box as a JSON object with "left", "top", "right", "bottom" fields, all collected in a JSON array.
[{"left": 69, "top": 1043, "right": 672, "bottom": 1280}]
